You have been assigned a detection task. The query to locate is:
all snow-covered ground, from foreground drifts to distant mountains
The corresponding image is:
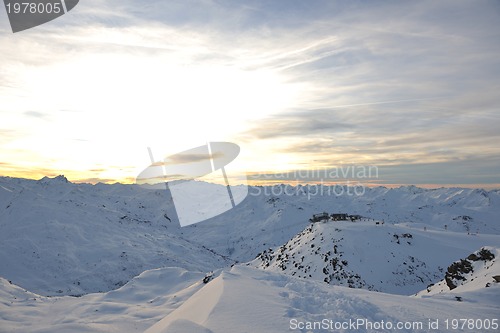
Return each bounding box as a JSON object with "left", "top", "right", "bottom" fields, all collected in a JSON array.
[{"left": 0, "top": 176, "right": 500, "bottom": 333}]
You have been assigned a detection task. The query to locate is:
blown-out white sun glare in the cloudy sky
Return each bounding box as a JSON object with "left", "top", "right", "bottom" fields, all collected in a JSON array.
[{"left": 2, "top": 35, "right": 301, "bottom": 180}]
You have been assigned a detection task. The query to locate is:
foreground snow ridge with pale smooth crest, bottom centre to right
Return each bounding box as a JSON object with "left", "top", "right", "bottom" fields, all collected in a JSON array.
[{"left": 145, "top": 266, "right": 500, "bottom": 333}]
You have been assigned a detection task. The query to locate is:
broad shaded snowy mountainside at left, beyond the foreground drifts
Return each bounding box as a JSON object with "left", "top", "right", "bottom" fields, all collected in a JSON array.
[{"left": 0, "top": 178, "right": 231, "bottom": 295}]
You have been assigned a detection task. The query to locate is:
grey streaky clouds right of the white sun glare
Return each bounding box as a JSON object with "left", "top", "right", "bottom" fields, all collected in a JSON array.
[{"left": 235, "top": 2, "right": 500, "bottom": 179}]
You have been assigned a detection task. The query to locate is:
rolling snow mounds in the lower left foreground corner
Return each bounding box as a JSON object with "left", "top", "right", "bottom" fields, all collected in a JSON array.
[{"left": 0, "top": 268, "right": 204, "bottom": 333}]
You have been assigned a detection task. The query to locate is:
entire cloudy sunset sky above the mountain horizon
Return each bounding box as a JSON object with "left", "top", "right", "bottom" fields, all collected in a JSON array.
[{"left": 0, "top": 0, "right": 500, "bottom": 188}]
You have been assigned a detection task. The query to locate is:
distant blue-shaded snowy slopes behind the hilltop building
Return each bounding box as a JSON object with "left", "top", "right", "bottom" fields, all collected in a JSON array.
[{"left": 183, "top": 185, "right": 500, "bottom": 262}]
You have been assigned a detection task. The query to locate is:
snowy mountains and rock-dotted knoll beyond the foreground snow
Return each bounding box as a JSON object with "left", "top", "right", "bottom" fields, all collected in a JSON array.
[{"left": 0, "top": 176, "right": 500, "bottom": 295}]
